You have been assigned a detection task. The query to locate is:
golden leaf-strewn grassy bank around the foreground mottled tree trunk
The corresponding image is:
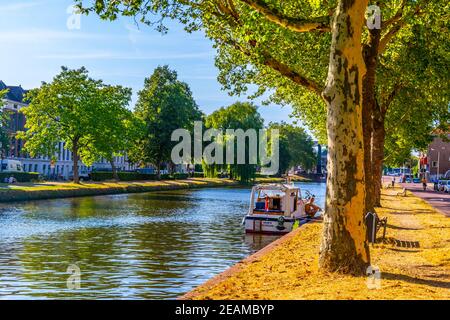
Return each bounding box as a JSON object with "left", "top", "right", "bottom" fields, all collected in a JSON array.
[{"left": 183, "top": 190, "right": 450, "bottom": 299}]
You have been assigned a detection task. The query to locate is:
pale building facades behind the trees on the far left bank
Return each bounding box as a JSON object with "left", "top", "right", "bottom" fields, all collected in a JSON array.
[{"left": 0, "top": 81, "right": 132, "bottom": 179}]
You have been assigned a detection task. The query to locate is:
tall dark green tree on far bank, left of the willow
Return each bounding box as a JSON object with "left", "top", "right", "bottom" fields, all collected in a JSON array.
[{"left": 134, "top": 66, "right": 201, "bottom": 177}]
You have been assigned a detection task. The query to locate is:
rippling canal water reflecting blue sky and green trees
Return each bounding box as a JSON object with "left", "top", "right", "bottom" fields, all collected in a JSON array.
[{"left": 0, "top": 183, "right": 325, "bottom": 299}]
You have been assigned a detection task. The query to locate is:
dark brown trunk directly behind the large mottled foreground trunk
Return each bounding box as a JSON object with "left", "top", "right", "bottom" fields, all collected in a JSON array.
[{"left": 362, "top": 28, "right": 381, "bottom": 212}]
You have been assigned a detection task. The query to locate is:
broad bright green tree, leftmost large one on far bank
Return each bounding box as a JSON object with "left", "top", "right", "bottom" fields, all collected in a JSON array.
[{"left": 17, "top": 67, "right": 122, "bottom": 183}]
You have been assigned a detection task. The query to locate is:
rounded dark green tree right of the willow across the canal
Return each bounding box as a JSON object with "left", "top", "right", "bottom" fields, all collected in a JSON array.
[{"left": 269, "top": 122, "right": 316, "bottom": 173}]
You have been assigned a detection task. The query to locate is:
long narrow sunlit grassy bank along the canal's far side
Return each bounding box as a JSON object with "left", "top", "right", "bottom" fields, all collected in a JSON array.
[{"left": 0, "top": 178, "right": 237, "bottom": 202}]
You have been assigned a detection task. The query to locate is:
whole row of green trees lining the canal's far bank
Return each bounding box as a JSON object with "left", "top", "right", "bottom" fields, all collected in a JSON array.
[{"left": 8, "top": 66, "right": 314, "bottom": 183}]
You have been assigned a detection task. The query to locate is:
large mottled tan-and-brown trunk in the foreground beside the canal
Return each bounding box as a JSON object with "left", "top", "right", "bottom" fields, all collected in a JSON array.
[{"left": 319, "top": 0, "right": 370, "bottom": 275}]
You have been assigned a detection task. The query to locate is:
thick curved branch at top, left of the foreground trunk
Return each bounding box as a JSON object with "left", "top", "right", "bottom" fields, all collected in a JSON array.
[{"left": 240, "top": 0, "right": 331, "bottom": 32}]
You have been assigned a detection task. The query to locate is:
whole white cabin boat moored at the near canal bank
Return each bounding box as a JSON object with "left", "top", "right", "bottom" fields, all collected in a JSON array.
[{"left": 243, "top": 183, "right": 318, "bottom": 234}]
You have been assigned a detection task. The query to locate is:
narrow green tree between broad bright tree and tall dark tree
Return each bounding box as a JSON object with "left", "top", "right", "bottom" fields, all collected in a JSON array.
[{"left": 90, "top": 86, "right": 135, "bottom": 180}]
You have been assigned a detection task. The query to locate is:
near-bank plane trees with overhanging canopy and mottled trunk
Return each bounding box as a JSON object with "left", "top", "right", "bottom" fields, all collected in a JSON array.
[{"left": 76, "top": 0, "right": 450, "bottom": 274}]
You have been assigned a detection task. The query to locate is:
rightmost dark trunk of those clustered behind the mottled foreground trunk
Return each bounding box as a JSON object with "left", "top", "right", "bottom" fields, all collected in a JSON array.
[{"left": 372, "top": 103, "right": 386, "bottom": 207}]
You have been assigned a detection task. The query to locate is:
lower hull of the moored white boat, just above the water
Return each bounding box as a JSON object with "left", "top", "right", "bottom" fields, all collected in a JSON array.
[{"left": 244, "top": 215, "right": 295, "bottom": 234}]
